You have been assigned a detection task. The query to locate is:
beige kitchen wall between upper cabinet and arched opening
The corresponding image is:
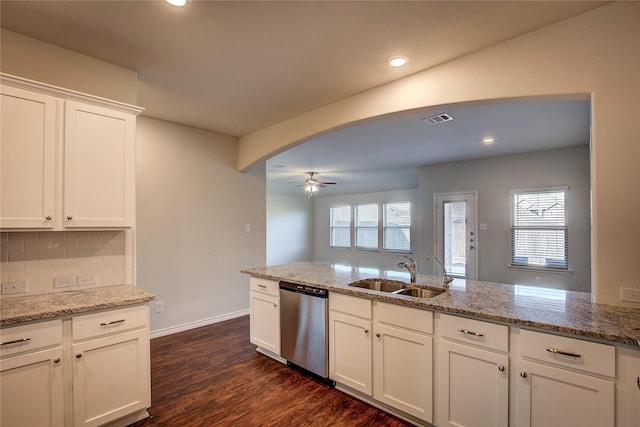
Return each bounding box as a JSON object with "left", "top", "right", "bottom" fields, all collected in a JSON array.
[{"left": 136, "top": 117, "right": 266, "bottom": 335}]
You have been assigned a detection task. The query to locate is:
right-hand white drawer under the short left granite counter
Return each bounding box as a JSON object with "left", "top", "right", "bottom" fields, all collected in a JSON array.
[{"left": 72, "top": 305, "right": 147, "bottom": 341}]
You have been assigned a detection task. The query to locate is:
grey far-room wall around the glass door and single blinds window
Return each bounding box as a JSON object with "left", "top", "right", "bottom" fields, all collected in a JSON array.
[{"left": 420, "top": 145, "right": 591, "bottom": 292}]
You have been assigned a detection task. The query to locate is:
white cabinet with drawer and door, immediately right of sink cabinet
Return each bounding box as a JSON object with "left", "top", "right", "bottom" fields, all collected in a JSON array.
[{"left": 436, "top": 314, "right": 509, "bottom": 427}]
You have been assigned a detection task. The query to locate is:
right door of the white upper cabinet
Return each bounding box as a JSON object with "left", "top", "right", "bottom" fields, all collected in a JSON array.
[{"left": 64, "top": 101, "right": 136, "bottom": 227}]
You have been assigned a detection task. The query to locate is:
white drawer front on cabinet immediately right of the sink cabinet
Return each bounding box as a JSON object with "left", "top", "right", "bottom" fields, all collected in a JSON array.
[{"left": 439, "top": 314, "right": 509, "bottom": 353}]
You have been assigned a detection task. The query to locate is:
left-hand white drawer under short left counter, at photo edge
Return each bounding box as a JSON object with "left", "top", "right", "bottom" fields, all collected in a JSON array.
[{"left": 0, "top": 319, "right": 62, "bottom": 356}]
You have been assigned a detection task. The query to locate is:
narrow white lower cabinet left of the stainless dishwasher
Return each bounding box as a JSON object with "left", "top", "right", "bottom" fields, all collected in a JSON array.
[{"left": 249, "top": 277, "right": 280, "bottom": 356}]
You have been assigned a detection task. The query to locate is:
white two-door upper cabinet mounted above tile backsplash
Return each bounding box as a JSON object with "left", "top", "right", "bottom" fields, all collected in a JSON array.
[{"left": 0, "top": 74, "right": 142, "bottom": 230}]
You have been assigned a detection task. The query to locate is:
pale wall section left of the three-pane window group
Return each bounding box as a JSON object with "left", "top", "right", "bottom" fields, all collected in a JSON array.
[{"left": 267, "top": 193, "right": 314, "bottom": 265}]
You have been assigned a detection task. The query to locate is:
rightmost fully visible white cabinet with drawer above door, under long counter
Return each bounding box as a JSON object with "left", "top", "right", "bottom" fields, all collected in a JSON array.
[{"left": 514, "top": 330, "right": 616, "bottom": 427}]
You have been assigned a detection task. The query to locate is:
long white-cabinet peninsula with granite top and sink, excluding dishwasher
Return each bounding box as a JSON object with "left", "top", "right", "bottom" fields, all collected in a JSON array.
[{"left": 242, "top": 262, "right": 640, "bottom": 427}]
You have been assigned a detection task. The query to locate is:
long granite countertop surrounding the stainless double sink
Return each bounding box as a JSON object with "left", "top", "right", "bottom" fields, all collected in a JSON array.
[{"left": 242, "top": 262, "right": 640, "bottom": 347}]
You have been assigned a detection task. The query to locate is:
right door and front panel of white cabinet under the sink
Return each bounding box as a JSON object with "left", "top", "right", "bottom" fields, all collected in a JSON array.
[{"left": 373, "top": 301, "right": 433, "bottom": 422}]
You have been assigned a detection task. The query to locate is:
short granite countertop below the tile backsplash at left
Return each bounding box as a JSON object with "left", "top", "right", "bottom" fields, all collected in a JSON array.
[{"left": 0, "top": 285, "right": 154, "bottom": 327}]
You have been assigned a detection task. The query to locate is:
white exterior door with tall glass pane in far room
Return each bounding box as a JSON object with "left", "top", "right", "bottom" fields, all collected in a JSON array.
[{"left": 435, "top": 193, "right": 478, "bottom": 280}]
